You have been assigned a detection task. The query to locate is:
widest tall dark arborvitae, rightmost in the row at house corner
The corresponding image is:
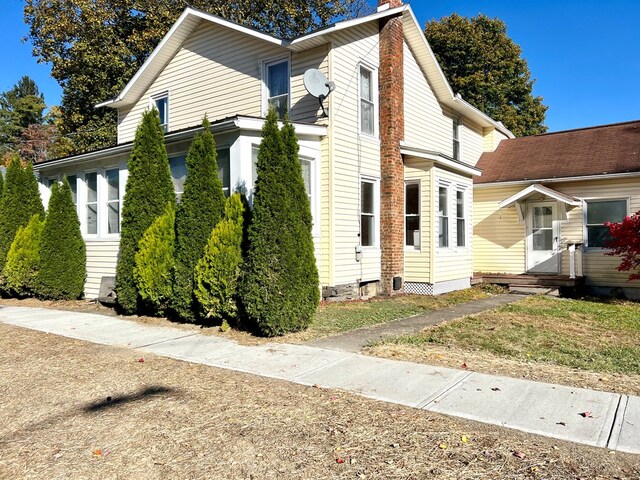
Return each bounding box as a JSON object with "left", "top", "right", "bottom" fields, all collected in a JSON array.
[{"left": 240, "top": 110, "right": 319, "bottom": 336}]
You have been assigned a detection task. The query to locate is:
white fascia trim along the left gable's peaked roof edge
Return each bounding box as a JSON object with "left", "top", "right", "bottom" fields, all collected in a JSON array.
[{"left": 95, "top": 7, "right": 286, "bottom": 108}]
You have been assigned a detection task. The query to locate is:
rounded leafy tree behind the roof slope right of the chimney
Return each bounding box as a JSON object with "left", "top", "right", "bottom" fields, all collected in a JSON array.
[{"left": 425, "top": 13, "right": 547, "bottom": 136}]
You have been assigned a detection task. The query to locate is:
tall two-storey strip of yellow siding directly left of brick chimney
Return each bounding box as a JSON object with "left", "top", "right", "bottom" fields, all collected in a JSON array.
[{"left": 329, "top": 22, "right": 380, "bottom": 285}]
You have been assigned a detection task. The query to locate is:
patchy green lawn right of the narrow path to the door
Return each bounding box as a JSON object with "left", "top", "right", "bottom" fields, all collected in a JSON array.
[{"left": 374, "top": 296, "right": 640, "bottom": 375}]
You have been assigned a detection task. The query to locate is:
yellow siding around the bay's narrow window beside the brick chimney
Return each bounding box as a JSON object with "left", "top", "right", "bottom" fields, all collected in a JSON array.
[{"left": 404, "top": 159, "right": 433, "bottom": 283}]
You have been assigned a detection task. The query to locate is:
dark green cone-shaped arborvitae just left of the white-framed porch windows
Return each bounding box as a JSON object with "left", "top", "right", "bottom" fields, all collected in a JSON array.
[{"left": 37, "top": 177, "right": 87, "bottom": 300}]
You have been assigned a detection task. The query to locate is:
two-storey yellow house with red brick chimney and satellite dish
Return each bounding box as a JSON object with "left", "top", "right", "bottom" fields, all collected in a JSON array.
[{"left": 36, "top": 0, "right": 513, "bottom": 298}]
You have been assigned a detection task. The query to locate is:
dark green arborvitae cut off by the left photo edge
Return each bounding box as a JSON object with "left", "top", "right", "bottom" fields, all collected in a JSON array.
[{"left": 0, "top": 156, "right": 44, "bottom": 271}]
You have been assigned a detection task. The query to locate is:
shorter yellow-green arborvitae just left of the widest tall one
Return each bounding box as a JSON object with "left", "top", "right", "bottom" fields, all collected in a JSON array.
[{"left": 194, "top": 193, "right": 244, "bottom": 321}]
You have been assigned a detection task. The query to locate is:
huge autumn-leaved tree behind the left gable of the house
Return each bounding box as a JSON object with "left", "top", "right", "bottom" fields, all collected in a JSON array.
[{"left": 24, "top": 0, "right": 368, "bottom": 151}]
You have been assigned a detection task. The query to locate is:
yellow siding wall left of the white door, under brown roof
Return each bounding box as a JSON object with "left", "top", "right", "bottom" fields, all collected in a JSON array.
[{"left": 473, "top": 186, "right": 526, "bottom": 274}]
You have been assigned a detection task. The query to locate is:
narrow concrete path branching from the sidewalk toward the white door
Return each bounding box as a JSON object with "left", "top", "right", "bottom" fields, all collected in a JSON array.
[{"left": 309, "top": 294, "right": 525, "bottom": 352}]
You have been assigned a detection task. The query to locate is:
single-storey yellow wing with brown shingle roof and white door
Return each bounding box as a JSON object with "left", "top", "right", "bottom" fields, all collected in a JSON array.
[{"left": 473, "top": 121, "right": 640, "bottom": 298}]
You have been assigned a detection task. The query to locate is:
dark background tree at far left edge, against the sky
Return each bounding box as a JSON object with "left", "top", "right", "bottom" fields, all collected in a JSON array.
[{"left": 0, "top": 75, "right": 46, "bottom": 154}]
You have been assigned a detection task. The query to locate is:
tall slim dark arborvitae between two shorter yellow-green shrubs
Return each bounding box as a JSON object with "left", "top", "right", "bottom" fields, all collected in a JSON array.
[{"left": 172, "top": 117, "right": 225, "bottom": 321}]
